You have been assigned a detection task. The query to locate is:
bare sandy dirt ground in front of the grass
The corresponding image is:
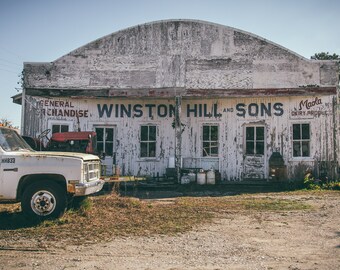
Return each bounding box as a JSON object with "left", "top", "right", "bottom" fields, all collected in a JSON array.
[{"left": 0, "top": 192, "right": 340, "bottom": 270}]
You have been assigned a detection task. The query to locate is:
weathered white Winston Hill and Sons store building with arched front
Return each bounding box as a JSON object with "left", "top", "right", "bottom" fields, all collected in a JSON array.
[{"left": 14, "top": 20, "right": 340, "bottom": 181}]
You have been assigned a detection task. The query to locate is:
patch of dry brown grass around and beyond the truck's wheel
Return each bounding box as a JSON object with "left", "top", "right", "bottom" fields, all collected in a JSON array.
[{"left": 0, "top": 191, "right": 318, "bottom": 244}]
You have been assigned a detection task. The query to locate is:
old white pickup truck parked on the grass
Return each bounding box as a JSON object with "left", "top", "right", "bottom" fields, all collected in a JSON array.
[{"left": 0, "top": 127, "right": 104, "bottom": 219}]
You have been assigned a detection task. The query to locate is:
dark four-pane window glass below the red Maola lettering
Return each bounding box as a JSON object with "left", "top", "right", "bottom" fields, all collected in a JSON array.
[{"left": 293, "top": 124, "right": 310, "bottom": 157}]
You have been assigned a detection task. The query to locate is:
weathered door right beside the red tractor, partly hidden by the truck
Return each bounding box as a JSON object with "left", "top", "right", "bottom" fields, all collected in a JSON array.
[{"left": 95, "top": 126, "right": 116, "bottom": 175}]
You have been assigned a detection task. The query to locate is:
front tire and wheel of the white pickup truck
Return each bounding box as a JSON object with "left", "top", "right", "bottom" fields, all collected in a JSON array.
[{"left": 21, "top": 182, "right": 67, "bottom": 219}]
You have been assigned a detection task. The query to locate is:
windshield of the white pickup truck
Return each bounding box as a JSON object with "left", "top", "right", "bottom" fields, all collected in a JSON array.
[{"left": 0, "top": 128, "right": 33, "bottom": 152}]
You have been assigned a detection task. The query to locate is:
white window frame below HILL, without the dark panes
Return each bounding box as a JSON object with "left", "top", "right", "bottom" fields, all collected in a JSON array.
[{"left": 201, "top": 123, "right": 220, "bottom": 158}]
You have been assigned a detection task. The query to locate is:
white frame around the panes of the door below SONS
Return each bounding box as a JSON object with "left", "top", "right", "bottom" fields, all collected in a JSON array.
[{"left": 244, "top": 125, "right": 266, "bottom": 156}]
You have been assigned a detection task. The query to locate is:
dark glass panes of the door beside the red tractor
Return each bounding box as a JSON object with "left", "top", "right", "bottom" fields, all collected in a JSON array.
[{"left": 95, "top": 127, "right": 114, "bottom": 156}]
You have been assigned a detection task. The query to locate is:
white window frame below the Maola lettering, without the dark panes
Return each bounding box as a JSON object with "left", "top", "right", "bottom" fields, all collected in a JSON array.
[{"left": 291, "top": 122, "right": 312, "bottom": 159}]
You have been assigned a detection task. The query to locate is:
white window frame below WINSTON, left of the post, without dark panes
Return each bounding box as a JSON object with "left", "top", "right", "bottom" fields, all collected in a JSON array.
[{"left": 139, "top": 124, "right": 158, "bottom": 159}]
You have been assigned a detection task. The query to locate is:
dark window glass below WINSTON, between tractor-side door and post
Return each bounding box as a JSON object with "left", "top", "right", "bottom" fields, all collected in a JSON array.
[{"left": 140, "top": 125, "right": 156, "bottom": 157}]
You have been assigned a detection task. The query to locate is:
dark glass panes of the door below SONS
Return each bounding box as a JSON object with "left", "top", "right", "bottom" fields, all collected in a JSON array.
[{"left": 246, "top": 126, "right": 264, "bottom": 155}]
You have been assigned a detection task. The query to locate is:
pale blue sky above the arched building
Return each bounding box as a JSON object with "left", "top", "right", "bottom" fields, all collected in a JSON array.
[{"left": 0, "top": 0, "right": 340, "bottom": 127}]
